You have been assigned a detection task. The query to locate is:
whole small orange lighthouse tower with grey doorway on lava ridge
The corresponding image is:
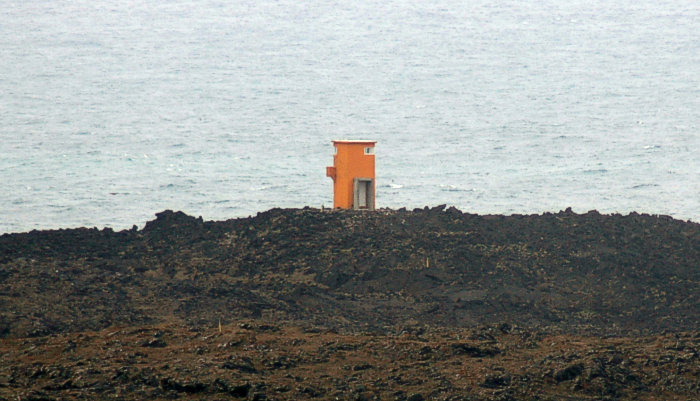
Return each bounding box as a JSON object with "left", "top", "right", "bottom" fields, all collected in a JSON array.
[{"left": 326, "top": 140, "right": 377, "bottom": 210}]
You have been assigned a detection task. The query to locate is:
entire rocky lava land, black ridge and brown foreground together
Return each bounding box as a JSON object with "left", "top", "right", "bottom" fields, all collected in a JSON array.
[{"left": 0, "top": 207, "right": 700, "bottom": 401}]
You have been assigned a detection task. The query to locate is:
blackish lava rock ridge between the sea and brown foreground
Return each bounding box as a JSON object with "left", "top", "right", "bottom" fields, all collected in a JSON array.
[{"left": 0, "top": 207, "right": 700, "bottom": 337}]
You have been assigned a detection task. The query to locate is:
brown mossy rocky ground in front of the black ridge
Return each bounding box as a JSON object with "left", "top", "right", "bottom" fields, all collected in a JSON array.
[{"left": 0, "top": 320, "right": 700, "bottom": 401}]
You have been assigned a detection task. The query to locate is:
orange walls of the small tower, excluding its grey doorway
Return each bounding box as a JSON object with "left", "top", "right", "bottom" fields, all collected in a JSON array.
[{"left": 327, "top": 141, "right": 376, "bottom": 209}]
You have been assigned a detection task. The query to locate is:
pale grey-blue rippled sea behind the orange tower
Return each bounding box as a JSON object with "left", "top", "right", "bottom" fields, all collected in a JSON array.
[{"left": 0, "top": 0, "right": 700, "bottom": 233}]
